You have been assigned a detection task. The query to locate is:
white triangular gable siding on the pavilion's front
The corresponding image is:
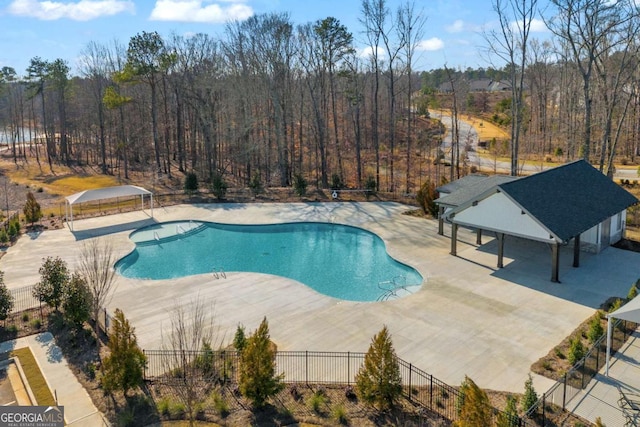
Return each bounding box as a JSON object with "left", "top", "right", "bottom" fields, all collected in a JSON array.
[{"left": 453, "top": 193, "right": 552, "bottom": 242}]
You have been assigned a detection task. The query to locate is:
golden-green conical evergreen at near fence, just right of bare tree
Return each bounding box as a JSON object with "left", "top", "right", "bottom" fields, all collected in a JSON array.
[{"left": 240, "top": 317, "right": 284, "bottom": 408}]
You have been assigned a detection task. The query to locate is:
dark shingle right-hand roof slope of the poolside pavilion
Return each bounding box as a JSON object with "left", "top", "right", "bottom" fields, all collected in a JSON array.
[{"left": 499, "top": 160, "right": 638, "bottom": 241}]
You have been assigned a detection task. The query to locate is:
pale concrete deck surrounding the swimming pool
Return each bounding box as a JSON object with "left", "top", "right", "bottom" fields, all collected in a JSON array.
[{"left": 0, "top": 202, "right": 640, "bottom": 394}]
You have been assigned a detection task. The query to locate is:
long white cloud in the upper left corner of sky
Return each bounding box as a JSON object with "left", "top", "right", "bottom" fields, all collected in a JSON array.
[{"left": 7, "top": 0, "right": 135, "bottom": 21}]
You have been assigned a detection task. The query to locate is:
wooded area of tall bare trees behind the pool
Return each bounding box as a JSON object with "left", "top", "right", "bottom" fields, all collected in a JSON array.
[{"left": 0, "top": 0, "right": 640, "bottom": 193}]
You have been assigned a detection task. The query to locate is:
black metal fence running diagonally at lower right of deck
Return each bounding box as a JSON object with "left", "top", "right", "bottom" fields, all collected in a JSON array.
[{"left": 526, "top": 319, "right": 638, "bottom": 419}]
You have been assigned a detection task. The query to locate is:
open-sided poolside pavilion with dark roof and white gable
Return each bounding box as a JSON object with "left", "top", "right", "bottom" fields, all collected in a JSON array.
[{"left": 436, "top": 160, "right": 638, "bottom": 282}]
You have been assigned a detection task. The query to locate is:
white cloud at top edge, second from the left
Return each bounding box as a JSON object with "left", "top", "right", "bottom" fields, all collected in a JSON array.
[{"left": 149, "top": 0, "right": 253, "bottom": 24}]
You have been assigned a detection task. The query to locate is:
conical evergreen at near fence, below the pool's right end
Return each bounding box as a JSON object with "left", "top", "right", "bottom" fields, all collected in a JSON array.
[{"left": 356, "top": 326, "right": 402, "bottom": 411}]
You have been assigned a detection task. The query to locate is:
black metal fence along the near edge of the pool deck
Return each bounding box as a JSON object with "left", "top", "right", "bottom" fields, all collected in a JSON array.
[{"left": 144, "top": 350, "right": 536, "bottom": 427}]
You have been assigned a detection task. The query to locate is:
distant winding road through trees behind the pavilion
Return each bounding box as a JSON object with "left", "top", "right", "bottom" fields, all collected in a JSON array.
[{"left": 431, "top": 111, "right": 640, "bottom": 181}]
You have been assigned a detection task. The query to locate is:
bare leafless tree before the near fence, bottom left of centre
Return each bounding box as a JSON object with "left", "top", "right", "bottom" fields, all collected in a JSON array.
[{"left": 162, "top": 295, "right": 224, "bottom": 425}]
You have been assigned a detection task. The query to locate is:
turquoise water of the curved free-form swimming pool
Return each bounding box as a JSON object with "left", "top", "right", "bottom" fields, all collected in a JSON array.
[{"left": 116, "top": 222, "right": 422, "bottom": 301}]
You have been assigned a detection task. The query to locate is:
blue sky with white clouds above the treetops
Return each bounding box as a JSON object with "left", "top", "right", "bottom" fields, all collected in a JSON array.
[{"left": 0, "top": 0, "right": 546, "bottom": 76}]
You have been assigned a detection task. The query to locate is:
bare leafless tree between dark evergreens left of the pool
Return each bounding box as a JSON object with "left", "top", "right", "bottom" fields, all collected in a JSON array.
[{"left": 79, "top": 239, "right": 116, "bottom": 354}]
